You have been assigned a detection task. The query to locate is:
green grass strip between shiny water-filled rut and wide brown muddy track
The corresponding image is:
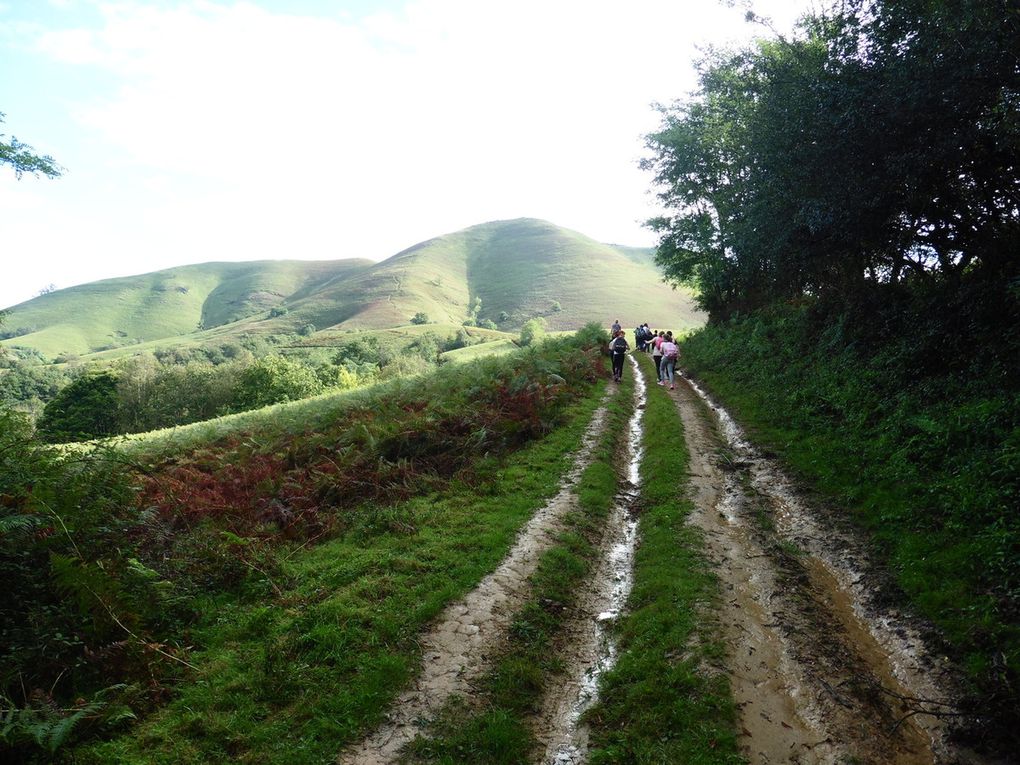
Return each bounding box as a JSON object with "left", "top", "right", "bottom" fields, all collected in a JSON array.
[{"left": 587, "top": 357, "right": 744, "bottom": 765}]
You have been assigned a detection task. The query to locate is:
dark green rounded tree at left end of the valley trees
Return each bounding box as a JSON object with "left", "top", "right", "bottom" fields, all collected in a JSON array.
[{"left": 38, "top": 371, "right": 117, "bottom": 444}]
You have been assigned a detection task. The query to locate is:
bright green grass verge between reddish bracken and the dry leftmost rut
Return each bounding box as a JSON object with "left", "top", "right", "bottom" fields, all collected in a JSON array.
[{"left": 75, "top": 385, "right": 604, "bottom": 765}]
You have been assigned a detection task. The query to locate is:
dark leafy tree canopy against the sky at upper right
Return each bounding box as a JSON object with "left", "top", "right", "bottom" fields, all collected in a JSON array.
[{"left": 644, "top": 0, "right": 1020, "bottom": 318}]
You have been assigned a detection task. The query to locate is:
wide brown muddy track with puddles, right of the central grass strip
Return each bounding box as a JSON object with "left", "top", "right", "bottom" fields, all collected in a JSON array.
[{"left": 673, "top": 369, "right": 976, "bottom": 765}]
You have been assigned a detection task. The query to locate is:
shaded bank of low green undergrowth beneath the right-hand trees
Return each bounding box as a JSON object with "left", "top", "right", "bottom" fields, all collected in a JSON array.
[{"left": 682, "top": 293, "right": 1020, "bottom": 744}]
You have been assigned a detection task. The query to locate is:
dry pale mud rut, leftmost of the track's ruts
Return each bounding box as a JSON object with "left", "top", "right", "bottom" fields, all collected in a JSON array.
[{"left": 337, "top": 397, "right": 606, "bottom": 765}]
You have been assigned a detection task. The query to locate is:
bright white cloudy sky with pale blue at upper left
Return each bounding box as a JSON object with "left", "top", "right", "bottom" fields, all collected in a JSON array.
[{"left": 0, "top": 0, "right": 811, "bottom": 307}]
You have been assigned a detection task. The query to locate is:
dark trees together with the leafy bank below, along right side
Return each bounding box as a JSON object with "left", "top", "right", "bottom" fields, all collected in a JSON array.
[{"left": 645, "top": 0, "right": 1020, "bottom": 752}]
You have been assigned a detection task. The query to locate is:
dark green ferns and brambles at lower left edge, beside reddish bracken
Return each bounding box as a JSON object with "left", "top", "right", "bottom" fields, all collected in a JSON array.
[{"left": 0, "top": 409, "right": 175, "bottom": 761}]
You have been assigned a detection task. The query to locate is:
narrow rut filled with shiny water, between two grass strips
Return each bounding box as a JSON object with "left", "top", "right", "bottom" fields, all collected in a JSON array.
[{"left": 534, "top": 358, "right": 647, "bottom": 765}]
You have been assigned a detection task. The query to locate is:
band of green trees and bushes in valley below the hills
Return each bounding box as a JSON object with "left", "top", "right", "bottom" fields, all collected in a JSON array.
[{"left": 0, "top": 330, "right": 483, "bottom": 443}]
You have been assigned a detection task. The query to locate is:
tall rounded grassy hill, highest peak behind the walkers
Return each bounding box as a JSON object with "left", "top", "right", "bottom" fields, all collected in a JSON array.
[{"left": 295, "top": 218, "right": 703, "bottom": 330}]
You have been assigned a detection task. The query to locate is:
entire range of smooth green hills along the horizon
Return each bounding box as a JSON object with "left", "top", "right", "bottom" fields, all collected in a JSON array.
[{"left": 4, "top": 218, "right": 704, "bottom": 359}]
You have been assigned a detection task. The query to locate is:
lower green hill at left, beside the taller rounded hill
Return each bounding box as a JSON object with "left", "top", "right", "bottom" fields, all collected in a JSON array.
[{"left": 5, "top": 260, "right": 369, "bottom": 357}]
